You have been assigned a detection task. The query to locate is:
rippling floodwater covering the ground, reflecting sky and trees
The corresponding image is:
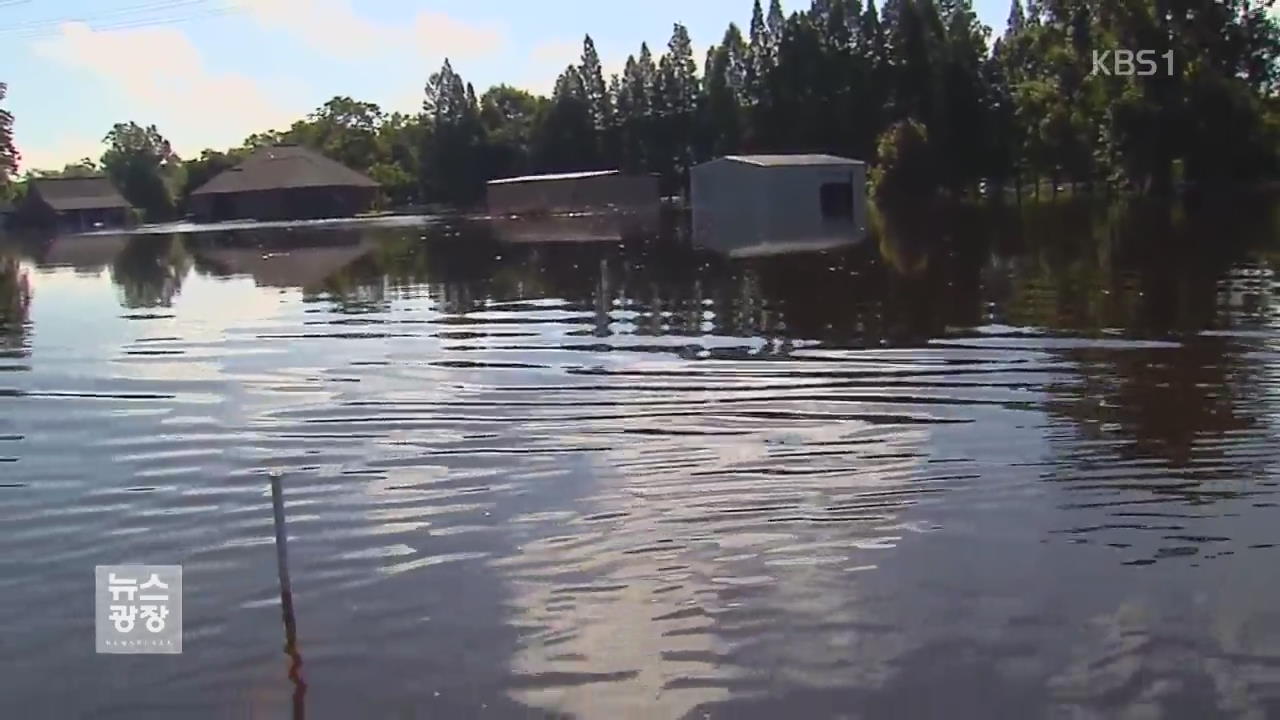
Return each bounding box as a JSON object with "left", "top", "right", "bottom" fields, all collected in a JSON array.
[{"left": 0, "top": 194, "right": 1280, "bottom": 720}]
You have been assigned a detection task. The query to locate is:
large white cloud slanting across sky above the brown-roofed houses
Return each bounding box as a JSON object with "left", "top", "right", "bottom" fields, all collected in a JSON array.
[{"left": 24, "top": 23, "right": 301, "bottom": 168}]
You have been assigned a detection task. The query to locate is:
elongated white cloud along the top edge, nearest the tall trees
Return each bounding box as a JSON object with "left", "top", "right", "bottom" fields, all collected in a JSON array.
[{"left": 236, "top": 0, "right": 507, "bottom": 59}]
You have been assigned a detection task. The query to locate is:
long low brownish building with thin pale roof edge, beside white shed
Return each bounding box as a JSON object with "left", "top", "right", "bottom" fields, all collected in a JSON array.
[{"left": 486, "top": 170, "right": 659, "bottom": 215}]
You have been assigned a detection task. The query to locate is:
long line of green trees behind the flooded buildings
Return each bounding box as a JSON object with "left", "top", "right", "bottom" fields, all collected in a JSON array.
[{"left": 0, "top": 0, "right": 1280, "bottom": 217}]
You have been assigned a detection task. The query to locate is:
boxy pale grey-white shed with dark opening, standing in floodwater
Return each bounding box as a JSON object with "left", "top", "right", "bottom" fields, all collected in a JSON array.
[{"left": 690, "top": 155, "right": 867, "bottom": 250}]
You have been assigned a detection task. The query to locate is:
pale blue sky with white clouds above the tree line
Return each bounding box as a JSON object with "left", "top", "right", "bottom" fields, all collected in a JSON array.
[{"left": 0, "top": 0, "right": 1007, "bottom": 169}]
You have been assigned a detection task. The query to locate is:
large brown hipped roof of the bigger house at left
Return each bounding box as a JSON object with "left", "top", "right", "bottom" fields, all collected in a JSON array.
[{"left": 192, "top": 145, "right": 379, "bottom": 195}]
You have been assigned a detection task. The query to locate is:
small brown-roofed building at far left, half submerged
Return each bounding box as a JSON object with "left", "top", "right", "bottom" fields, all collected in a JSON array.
[{"left": 17, "top": 177, "right": 132, "bottom": 232}]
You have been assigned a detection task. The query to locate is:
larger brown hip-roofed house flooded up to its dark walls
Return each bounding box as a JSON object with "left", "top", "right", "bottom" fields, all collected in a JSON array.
[{"left": 189, "top": 145, "right": 379, "bottom": 222}]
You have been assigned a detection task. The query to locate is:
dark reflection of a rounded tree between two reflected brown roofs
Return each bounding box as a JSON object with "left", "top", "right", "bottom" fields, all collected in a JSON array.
[{"left": 111, "top": 236, "right": 192, "bottom": 307}]
